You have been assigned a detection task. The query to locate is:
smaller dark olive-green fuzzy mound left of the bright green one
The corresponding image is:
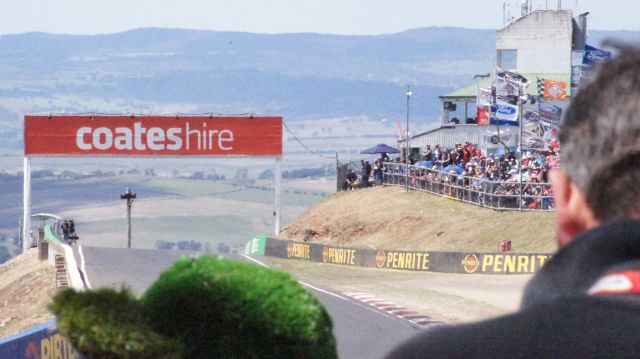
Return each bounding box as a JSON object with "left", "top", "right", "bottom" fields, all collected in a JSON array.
[{"left": 49, "top": 289, "right": 182, "bottom": 359}]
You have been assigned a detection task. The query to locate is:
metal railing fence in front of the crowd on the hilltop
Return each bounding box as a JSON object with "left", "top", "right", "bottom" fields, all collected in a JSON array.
[{"left": 384, "top": 163, "right": 553, "bottom": 211}]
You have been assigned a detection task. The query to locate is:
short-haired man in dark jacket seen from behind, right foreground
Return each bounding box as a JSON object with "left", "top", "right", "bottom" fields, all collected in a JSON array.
[{"left": 389, "top": 47, "right": 640, "bottom": 358}]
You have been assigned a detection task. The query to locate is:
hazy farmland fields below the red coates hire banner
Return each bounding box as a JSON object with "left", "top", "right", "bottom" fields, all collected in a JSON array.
[{"left": 0, "top": 175, "right": 335, "bottom": 250}]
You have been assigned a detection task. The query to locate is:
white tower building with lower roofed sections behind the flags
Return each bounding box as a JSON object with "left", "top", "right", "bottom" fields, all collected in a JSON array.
[{"left": 399, "top": 9, "right": 587, "bottom": 159}]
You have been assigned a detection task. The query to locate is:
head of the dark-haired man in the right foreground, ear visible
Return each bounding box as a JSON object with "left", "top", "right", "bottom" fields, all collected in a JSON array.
[{"left": 550, "top": 47, "right": 640, "bottom": 246}]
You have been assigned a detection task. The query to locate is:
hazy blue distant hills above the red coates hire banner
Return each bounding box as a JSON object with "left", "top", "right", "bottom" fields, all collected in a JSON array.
[{"left": 0, "top": 28, "right": 640, "bottom": 148}]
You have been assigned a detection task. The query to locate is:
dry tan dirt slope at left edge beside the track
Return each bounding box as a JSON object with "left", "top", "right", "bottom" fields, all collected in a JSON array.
[{"left": 0, "top": 249, "right": 56, "bottom": 338}]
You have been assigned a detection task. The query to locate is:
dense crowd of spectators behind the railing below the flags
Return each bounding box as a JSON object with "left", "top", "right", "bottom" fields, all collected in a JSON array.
[{"left": 387, "top": 142, "right": 558, "bottom": 209}]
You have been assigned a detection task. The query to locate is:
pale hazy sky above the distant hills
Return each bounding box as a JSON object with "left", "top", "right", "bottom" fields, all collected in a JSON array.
[{"left": 0, "top": 0, "right": 640, "bottom": 34}]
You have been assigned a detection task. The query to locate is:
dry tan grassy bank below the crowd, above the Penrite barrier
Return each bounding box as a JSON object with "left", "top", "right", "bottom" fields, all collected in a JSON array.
[{"left": 278, "top": 187, "right": 556, "bottom": 252}]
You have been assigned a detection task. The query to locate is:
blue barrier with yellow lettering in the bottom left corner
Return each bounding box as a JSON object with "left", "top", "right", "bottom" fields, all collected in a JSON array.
[{"left": 0, "top": 322, "right": 84, "bottom": 359}]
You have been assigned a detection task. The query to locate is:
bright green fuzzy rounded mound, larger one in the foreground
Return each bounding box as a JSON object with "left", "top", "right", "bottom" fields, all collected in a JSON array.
[{"left": 141, "top": 257, "right": 337, "bottom": 358}]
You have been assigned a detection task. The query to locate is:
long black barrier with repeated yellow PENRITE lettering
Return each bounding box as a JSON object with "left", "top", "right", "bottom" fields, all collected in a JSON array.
[{"left": 258, "top": 238, "right": 551, "bottom": 274}]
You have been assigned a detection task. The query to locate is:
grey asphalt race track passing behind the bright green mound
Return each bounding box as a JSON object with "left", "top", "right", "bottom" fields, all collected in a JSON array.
[{"left": 74, "top": 247, "right": 419, "bottom": 359}]
